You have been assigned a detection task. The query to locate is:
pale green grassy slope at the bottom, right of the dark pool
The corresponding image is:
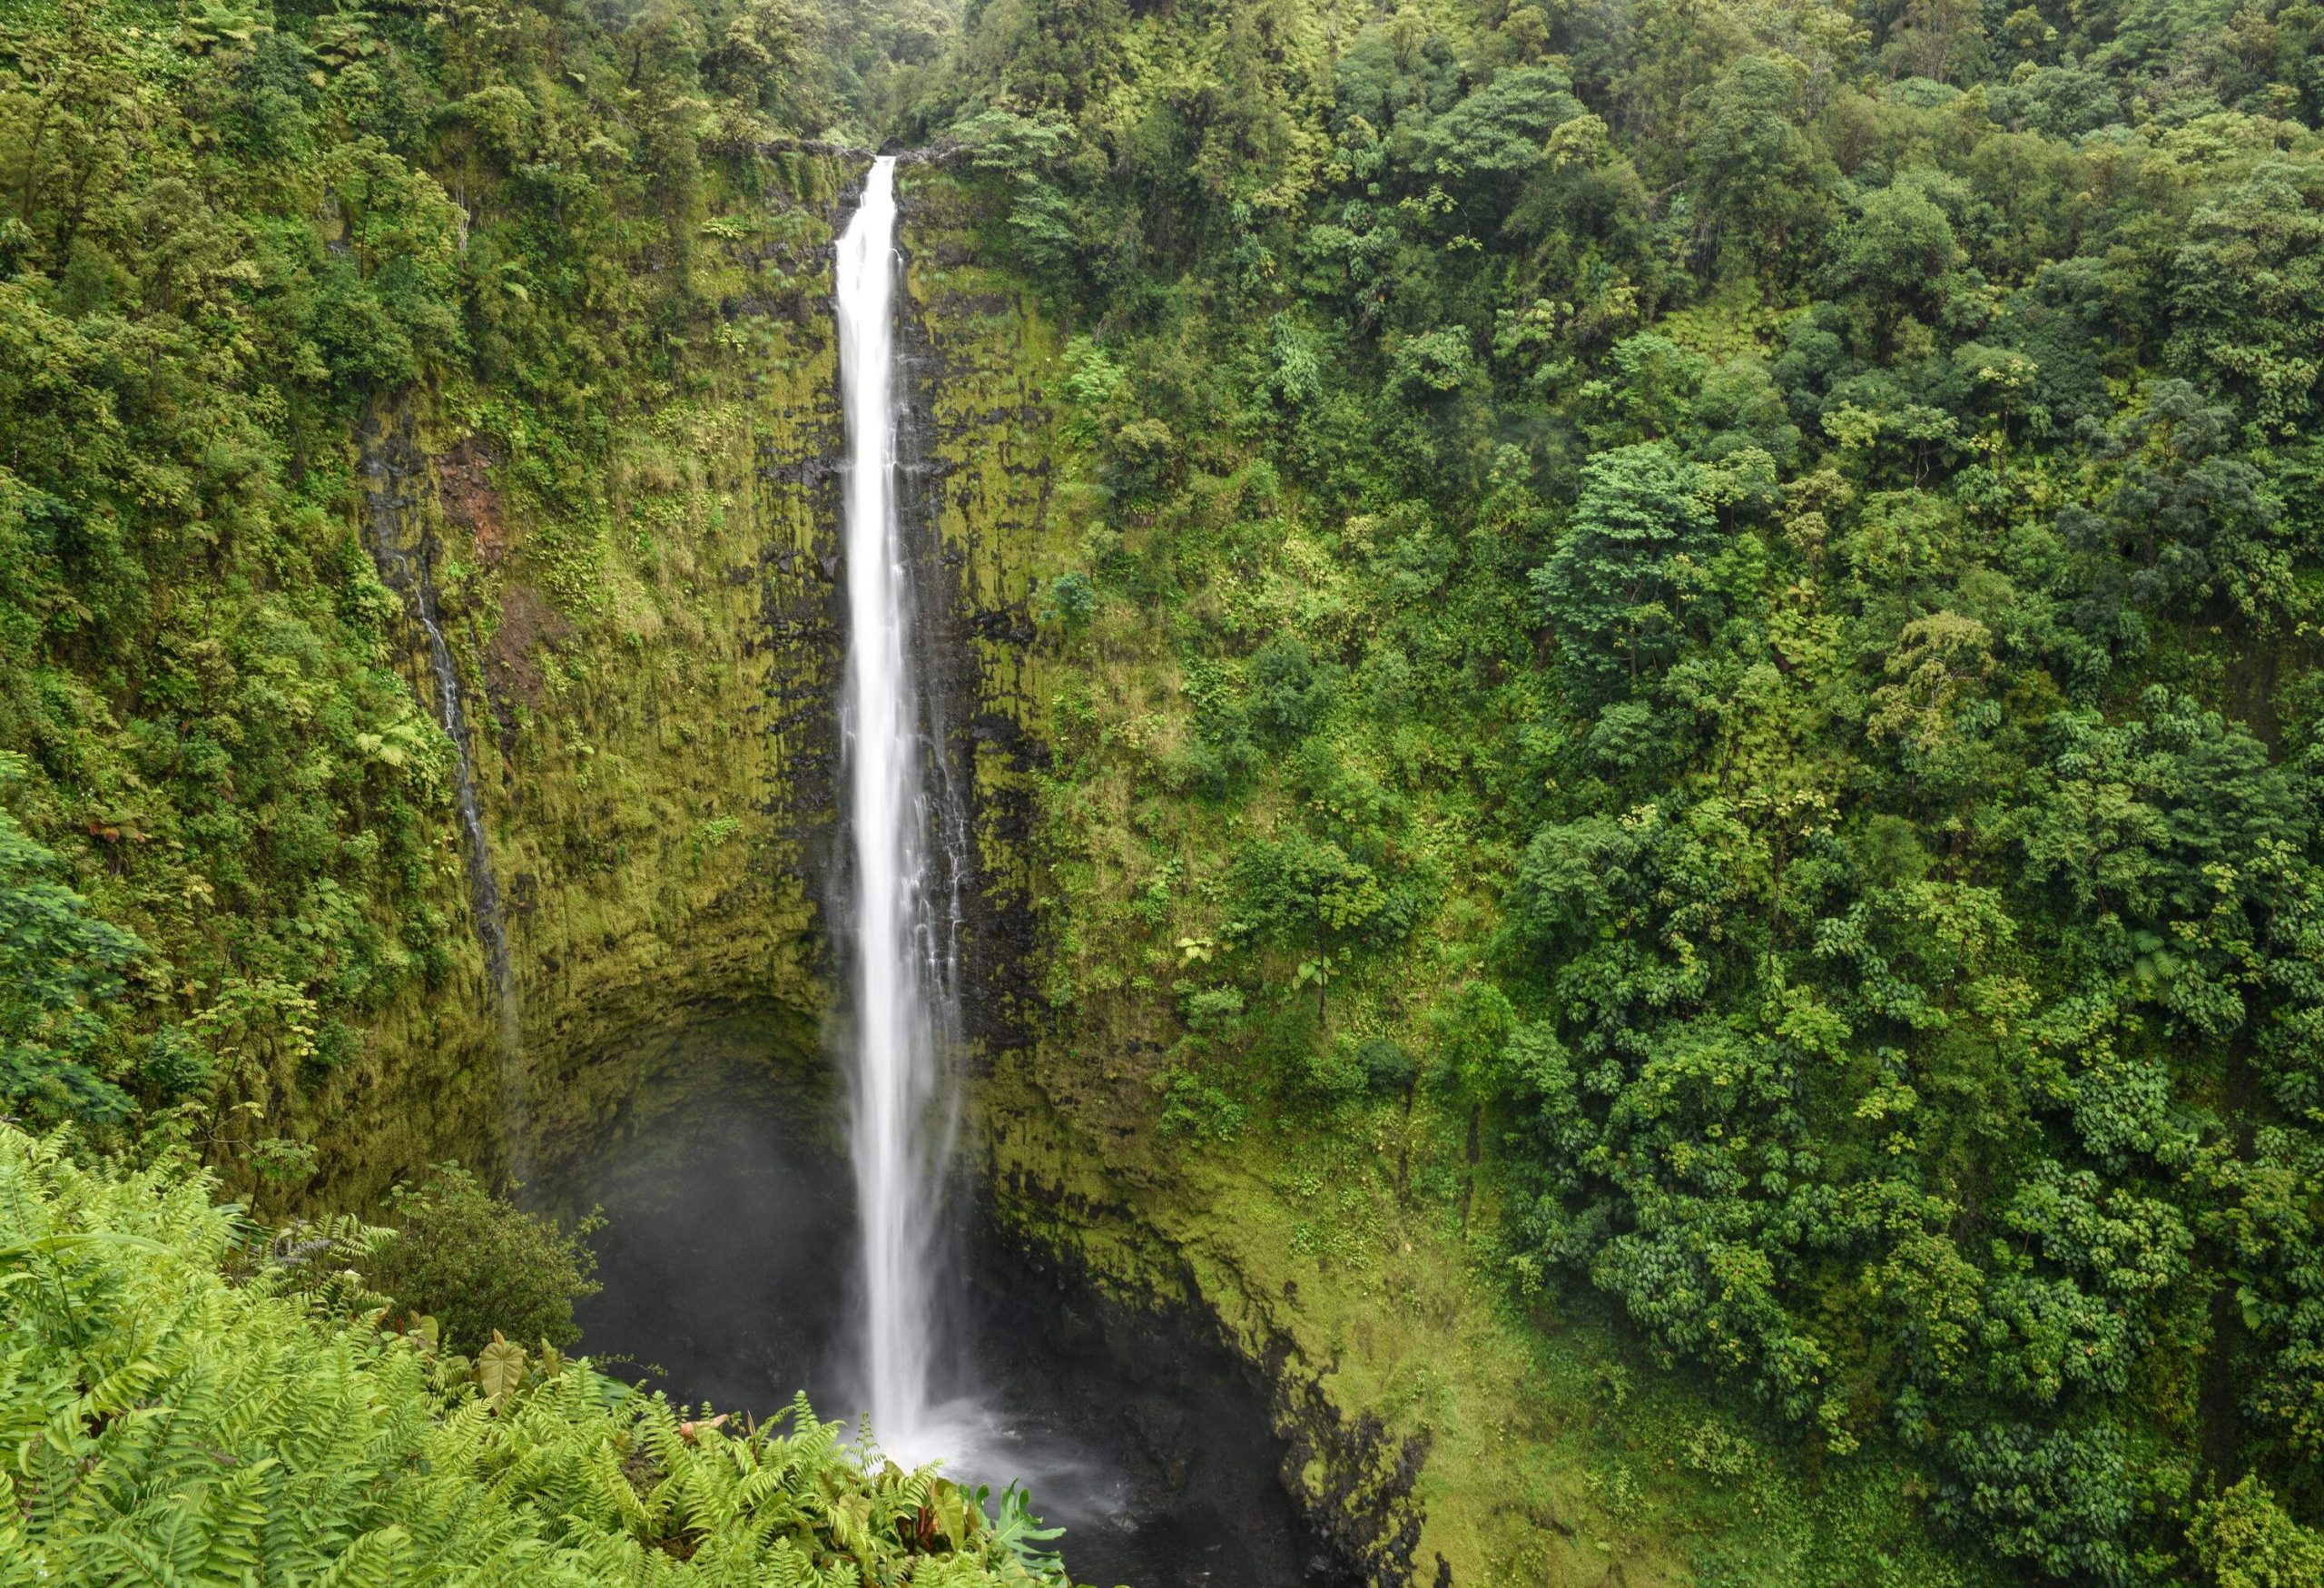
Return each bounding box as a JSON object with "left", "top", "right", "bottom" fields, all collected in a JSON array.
[{"left": 1186, "top": 1125, "right": 1992, "bottom": 1588}]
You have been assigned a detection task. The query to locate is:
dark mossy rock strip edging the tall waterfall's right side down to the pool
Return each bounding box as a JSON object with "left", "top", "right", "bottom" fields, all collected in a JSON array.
[{"left": 904, "top": 167, "right": 1436, "bottom": 1588}]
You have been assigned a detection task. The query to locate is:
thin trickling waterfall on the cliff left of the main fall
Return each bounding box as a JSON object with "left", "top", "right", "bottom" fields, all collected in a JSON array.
[{"left": 358, "top": 409, "right": 532, "bottom": 1181}]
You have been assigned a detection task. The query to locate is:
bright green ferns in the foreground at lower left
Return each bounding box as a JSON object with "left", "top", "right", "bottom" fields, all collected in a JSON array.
[{"left": 0, "top": 1125, "right": 1064, "bottom": 1588}]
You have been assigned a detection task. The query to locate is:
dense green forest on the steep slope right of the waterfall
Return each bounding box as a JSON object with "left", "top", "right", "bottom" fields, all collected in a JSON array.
[{"left": 916, "top": 0, "right": 2324, "bottom": 1583}]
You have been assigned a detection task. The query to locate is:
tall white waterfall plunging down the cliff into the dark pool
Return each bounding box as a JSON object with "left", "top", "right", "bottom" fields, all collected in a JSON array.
[{"left": 839, "top": 156, "right": 960, "bottom": 1460}]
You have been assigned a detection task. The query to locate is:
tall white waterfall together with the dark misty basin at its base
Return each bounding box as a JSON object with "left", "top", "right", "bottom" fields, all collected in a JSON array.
[{"left": 502, "top": 145, "right": 1350, "bottom": 1588}]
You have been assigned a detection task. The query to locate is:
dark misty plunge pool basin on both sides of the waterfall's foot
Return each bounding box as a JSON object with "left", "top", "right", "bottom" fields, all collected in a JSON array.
[{"left": 539, "top": 1016, "right": 1336, "bottom": 1588}]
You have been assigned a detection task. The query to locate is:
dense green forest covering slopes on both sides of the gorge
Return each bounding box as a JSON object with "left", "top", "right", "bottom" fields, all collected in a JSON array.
[{"left": 0, "top": 0, "right": 2324, "bottom": 1588}]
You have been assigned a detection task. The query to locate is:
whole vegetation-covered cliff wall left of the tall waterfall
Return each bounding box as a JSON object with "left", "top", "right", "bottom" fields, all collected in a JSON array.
[{"left": 0, "top": 0, "right": 890, "bottom": 1204}]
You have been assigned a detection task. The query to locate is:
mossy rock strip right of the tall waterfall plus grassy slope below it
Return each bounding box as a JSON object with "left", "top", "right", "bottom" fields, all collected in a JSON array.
[{"left": 878, "top": 167, "right": 1980, "bottom": 1588}]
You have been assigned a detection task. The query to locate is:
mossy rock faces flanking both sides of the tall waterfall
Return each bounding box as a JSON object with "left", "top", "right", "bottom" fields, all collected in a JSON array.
[{"left": 322, "top": 156, "right": 1427, "bottom": 1583}]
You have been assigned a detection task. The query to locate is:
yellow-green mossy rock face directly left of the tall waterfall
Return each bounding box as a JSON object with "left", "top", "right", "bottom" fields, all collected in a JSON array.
[{"left": 301, "top": 156, "right": 848, "bottom": 1207}]
